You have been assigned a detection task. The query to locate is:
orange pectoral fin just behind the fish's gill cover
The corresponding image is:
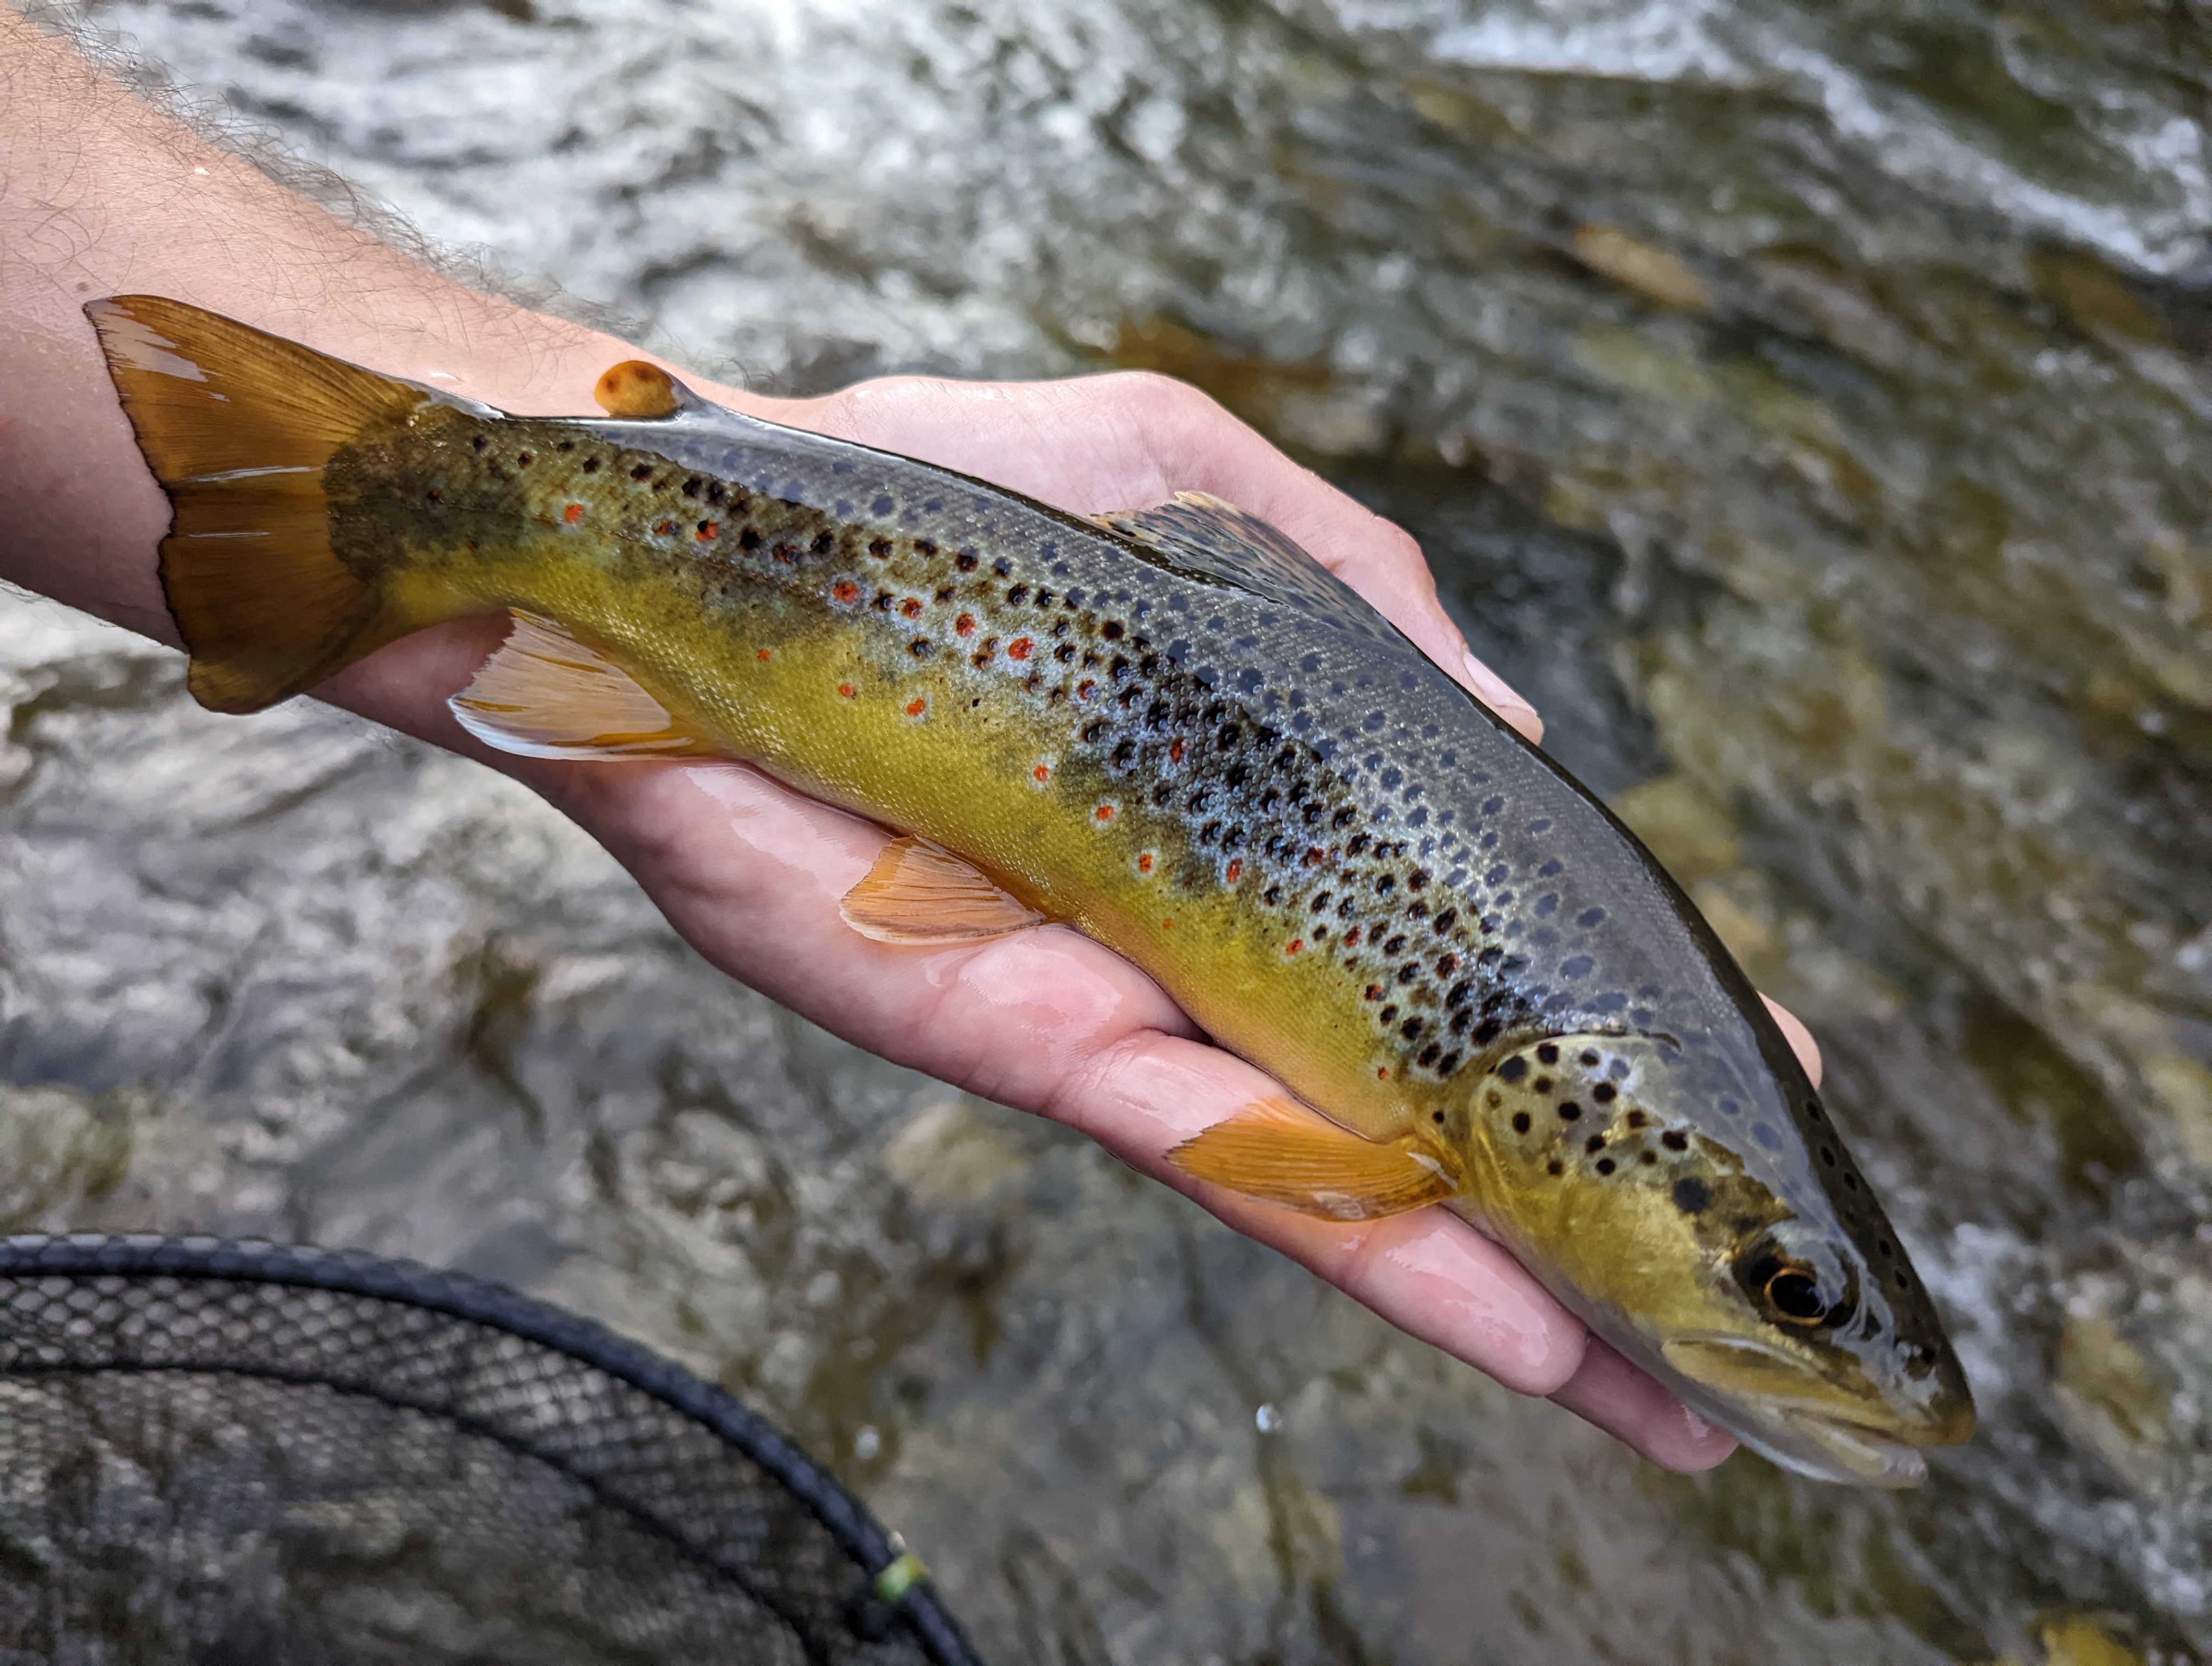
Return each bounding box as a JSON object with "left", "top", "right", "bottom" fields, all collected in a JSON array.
[{"left": 1168, "top": 1100, "right": 1460, "bottom": 1221}]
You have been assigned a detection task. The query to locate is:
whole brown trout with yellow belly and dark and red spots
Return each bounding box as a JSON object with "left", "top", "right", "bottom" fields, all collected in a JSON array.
[{"left": 86, "top": 294, "right": 1973, "bottom": 1487}]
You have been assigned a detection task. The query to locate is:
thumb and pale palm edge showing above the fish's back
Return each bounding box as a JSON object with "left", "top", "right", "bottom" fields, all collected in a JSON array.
[{"left": 785, "top": 371, "right": 1544, "bottom": 741}]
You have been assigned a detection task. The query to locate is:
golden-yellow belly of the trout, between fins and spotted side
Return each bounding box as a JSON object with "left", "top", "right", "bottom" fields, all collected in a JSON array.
[{"left": 447, "top": 542, "right": 1436, "bottom": 1133}]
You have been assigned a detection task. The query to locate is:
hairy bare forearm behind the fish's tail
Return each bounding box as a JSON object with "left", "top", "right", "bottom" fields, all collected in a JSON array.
[{"left": 0, "top": 2, "right": 761, "bottom": 646}]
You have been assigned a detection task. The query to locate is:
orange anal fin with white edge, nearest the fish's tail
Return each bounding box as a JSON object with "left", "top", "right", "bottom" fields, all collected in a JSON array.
[{"left": 447, "top": 613, "right": 728, "bottom": 759}]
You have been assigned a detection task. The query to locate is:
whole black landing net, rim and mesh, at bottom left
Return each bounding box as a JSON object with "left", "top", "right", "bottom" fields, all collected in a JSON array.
[{"left": 0, "top": 1237, "right": 973, "bottom": 1666}]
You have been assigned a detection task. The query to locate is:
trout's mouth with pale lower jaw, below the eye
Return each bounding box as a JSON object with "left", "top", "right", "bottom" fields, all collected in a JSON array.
[{"left": 1661, "top": 1336, "right": 1962, "bottom": 1489}]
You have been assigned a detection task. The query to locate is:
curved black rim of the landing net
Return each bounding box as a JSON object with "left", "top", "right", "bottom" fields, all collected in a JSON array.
[{"left": 0, "top": 1232, "right": 982, "bottom": 1666}]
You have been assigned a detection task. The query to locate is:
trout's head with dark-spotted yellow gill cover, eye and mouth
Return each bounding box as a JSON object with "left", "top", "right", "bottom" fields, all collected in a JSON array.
[{"left": 1462, "top": 1033, "right": 1973, "bottom": 1487}]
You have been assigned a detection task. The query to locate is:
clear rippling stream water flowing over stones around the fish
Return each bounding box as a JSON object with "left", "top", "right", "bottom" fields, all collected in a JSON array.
[{"left": 12, "top": 0, "right": 2212, "bottom": 1666}]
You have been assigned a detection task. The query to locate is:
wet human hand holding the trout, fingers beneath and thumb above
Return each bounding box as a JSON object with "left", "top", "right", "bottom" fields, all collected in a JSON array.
[{"left": 325, "top": 360, "right": 1818, "bottom": 1469}]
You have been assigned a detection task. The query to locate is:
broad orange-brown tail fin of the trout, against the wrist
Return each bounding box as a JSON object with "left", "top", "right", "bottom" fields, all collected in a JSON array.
[{"left": 84, "top": 294, "right": 438, "bottom": 713}]
